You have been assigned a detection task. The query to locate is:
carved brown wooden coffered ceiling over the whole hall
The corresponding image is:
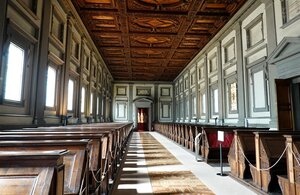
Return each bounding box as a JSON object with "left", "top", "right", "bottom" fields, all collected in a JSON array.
[{"left": 72, "top": 0, "right": 246, "bottom": 81}]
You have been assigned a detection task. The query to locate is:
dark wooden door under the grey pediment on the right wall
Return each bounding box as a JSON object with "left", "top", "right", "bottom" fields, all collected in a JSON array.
[{"left": 275, "top": 79, "right": 294, "bottom": 131}]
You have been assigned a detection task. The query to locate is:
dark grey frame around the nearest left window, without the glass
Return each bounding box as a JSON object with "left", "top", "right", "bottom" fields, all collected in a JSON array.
[{"left": 0, "top": 19, "right": 37, "bottom": 114}]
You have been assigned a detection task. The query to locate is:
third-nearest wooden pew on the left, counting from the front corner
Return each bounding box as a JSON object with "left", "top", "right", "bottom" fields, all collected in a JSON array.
[{"left": 0, "top": 132, "right": 109, "bottom": 194}]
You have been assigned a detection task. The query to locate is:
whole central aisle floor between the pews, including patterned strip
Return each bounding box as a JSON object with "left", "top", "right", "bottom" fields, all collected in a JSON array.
[{"left": 112, "top": 132, "right": 255, "bottom": 195}]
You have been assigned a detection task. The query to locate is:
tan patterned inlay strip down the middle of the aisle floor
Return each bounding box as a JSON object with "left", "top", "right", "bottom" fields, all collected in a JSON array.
[{"left": 140, "top": 133, "right": 214, "bottom": 195}]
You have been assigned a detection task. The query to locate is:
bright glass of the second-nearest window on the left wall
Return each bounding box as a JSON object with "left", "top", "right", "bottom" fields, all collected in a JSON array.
[{"left": 46, "top": 66, "right": 56, "bottom": 107}]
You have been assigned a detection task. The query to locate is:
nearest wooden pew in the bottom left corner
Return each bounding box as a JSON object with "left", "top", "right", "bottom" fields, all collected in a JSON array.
[{"left": 0, "top": 150, "right": 68, "bottom": 195}]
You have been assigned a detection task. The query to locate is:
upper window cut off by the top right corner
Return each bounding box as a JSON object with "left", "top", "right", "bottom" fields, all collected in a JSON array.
[{"left": 281, "top": 0, "right": 300, "bottom": 24}]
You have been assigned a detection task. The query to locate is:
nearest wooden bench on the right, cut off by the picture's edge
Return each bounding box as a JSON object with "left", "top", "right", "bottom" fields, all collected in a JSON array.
[{"left": 277, "top": 135, "right": 300, "bottom": 195}]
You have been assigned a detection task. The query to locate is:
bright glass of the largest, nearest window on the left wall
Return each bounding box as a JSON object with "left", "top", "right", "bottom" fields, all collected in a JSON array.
[{"left": 4, "top": 42, "right": 25, "bottom": 102}]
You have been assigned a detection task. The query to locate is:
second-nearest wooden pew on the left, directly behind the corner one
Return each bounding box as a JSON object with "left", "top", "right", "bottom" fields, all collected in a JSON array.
[{"left": 0, "top": 139, "right": 90, "bottom": 195}]
